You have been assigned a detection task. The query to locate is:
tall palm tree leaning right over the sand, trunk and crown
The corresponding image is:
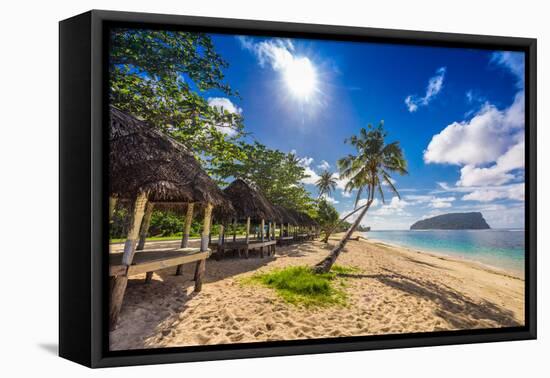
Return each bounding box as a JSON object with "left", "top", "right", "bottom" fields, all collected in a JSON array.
[{"left": 313, "top": 123, "right": 407, "bottom": 273}]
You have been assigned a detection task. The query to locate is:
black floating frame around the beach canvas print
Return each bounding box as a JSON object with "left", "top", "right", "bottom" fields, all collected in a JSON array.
[{"left": 59, "top": 10, "right": 537, "bottom": 367}]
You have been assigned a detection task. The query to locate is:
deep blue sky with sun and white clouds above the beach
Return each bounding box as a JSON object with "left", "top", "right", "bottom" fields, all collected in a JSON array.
[{"left": 202, "top": 35, "right": 525, "bottom": 229}]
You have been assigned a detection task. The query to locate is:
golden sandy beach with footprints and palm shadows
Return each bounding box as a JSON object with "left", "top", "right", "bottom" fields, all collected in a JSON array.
[{"left": 110, "top": 239, "right": 524, "bottom": 350}]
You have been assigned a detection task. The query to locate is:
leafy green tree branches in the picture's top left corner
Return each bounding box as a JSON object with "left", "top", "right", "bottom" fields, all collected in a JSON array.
[{"left": 109, "top": 28, "right": 243, "bottom": 165}]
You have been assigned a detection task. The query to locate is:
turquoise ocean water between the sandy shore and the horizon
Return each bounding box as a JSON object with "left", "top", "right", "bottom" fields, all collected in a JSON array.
[{"left": 364, "top": 230, "right": 525, "bottom": 276}]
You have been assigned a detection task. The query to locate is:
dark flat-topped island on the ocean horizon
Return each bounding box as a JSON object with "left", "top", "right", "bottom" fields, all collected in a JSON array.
[{"left": 411, "top": 212, "right": 491, "bottom": 230}]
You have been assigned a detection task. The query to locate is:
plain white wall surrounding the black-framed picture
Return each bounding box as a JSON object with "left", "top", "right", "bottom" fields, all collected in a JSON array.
[{"left": 0, "top": 0, "right": 550, "bottom": 377}]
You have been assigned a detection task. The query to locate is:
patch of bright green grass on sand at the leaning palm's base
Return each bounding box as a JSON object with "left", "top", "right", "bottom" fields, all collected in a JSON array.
[{"left": 243, "top": 265, "right": 359, "bottom": 307}]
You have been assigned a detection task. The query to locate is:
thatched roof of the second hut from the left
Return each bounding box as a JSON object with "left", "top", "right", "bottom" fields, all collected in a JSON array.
[{"left": 223, "top": 179, "right": 278, "bottom": 221}]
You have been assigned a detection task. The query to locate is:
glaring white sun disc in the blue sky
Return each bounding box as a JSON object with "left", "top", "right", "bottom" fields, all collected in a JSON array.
[{"left": 284, "top": 58, "right": 317, "bottom": 101}]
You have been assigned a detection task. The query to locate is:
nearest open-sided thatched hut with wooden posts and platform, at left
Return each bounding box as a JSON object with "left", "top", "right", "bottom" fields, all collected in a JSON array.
[{"left": 109, "top": 107, "right": 231, "bottom": 329}]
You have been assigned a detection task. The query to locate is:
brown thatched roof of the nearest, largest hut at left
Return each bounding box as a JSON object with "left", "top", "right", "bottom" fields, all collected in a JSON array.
[{"left": 109, "top": 106, "right": 231, "bottom": 207}]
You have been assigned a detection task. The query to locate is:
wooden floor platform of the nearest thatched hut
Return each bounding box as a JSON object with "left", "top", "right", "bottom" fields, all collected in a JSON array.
[{"left": 109, "top": 248, "right": 210, "bottom": 276}]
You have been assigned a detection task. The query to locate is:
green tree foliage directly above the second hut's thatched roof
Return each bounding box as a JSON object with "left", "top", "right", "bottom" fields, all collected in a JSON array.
[{"left": 213, "top": 142, "right": 315, "bottom": 215}]
